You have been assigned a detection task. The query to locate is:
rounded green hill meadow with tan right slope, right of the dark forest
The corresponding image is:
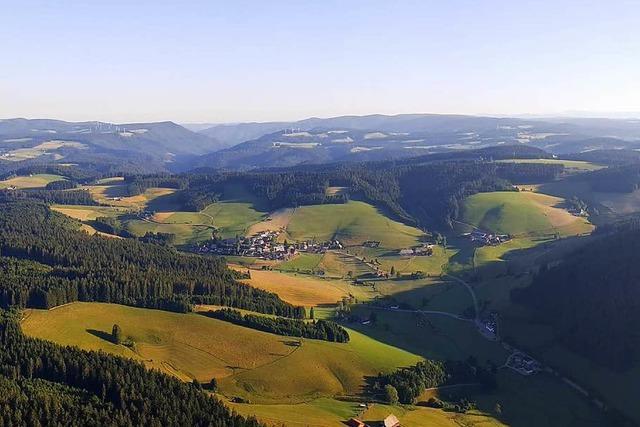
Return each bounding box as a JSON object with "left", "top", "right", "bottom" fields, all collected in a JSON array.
[{"left": 462, "top": 191, "right": 593, "bottom": 237}]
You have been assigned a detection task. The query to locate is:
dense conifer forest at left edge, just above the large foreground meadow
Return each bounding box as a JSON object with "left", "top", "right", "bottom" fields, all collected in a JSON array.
[{"left": 0, "top": 202, "right": 304, "bottom": 317}]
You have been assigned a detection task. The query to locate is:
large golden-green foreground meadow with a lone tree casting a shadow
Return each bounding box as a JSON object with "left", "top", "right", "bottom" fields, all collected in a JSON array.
[{"left": 23, "top": 303, "right": 419, "bottom": 403}]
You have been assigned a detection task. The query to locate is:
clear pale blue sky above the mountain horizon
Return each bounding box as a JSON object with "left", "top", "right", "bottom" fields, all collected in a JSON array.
[{"left": 0, "top": 0, "right": 640, "bottom": 122}]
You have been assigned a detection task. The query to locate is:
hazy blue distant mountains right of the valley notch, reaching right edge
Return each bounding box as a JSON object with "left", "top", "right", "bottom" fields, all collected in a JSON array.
[{"left": 193, "top": 114, "right": 640, "bottom": 170}]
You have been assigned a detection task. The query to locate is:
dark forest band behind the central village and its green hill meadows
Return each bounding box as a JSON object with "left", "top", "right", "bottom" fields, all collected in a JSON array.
[{"left": 181, "top": 155, "right": 563, "bottom": 227}]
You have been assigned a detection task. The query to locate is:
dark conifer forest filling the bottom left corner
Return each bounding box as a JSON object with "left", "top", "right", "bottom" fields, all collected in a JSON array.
[{"left": 0, "top": 311, "right": 260, "bottom": 427}]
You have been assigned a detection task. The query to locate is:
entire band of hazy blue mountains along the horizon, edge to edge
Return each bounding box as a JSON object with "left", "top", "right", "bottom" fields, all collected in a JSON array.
[{"left": 0, "top": 114, "right": 640, "bottom": 172}]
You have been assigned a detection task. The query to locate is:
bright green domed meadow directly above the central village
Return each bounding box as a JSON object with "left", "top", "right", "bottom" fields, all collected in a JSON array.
[{"left": 287, "top": 201, "right": 423, "bottom": 249}]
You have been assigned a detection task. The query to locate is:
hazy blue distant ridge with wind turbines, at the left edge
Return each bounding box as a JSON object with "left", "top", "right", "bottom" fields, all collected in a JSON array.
[{"left": 0, "top": 118, "right": 225, "bottom": 170}]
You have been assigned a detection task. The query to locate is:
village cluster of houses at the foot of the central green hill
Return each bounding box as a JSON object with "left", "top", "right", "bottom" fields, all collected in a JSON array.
[{"left": 196, "top": 230, "right": 343, "bottom": 260}]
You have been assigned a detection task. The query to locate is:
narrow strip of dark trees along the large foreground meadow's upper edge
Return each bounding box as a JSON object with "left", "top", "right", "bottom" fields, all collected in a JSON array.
[{"left": 204, "top": 308, "right": 349, "bottom": 343}]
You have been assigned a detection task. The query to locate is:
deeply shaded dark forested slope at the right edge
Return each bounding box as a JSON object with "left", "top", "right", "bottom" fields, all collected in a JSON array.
[{"left": 513, "top": 228, "right": 640, "bottom": 370}]
